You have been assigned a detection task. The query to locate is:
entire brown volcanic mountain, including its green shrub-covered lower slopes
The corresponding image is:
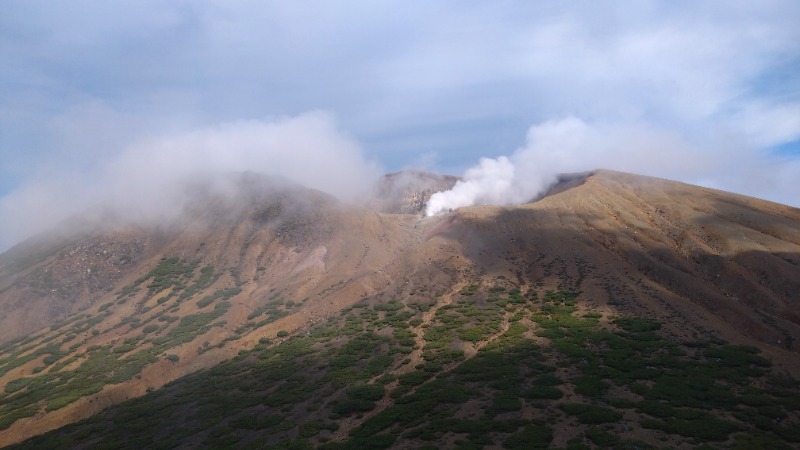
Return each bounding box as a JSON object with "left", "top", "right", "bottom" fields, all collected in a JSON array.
[{"left": 0, "top": 170, "right": 800, "bottom": 448}]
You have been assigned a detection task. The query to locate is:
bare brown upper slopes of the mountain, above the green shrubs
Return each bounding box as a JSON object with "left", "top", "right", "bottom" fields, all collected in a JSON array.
[{"left": 0, "top": 170, "right": 800, "bottom": 444}]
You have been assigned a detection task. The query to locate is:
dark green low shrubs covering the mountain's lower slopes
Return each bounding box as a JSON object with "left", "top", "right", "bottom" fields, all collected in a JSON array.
[{"left": 0, "top": 286, "right": 800, "bottom": 449}]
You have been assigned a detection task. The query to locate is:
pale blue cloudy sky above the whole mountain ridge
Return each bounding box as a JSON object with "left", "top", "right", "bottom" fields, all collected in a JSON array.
[{"left": 0, "top": 0, "right": 800, "bottom": 251}]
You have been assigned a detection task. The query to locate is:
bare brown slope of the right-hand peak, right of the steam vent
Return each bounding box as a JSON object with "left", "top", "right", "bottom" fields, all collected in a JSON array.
[{"left": 461, "top": 171, "right": 800, "bottom": 356}]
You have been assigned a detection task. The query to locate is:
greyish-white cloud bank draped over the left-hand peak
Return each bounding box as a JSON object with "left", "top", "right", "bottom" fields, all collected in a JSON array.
[{"left": 0, "top": 112, "right": 381, "bottom": 249}]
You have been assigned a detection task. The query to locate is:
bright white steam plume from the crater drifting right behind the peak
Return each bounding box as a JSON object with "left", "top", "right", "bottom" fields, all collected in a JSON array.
[{"left": 426, "top": 117, "right": 800, "bottom": 216}]
